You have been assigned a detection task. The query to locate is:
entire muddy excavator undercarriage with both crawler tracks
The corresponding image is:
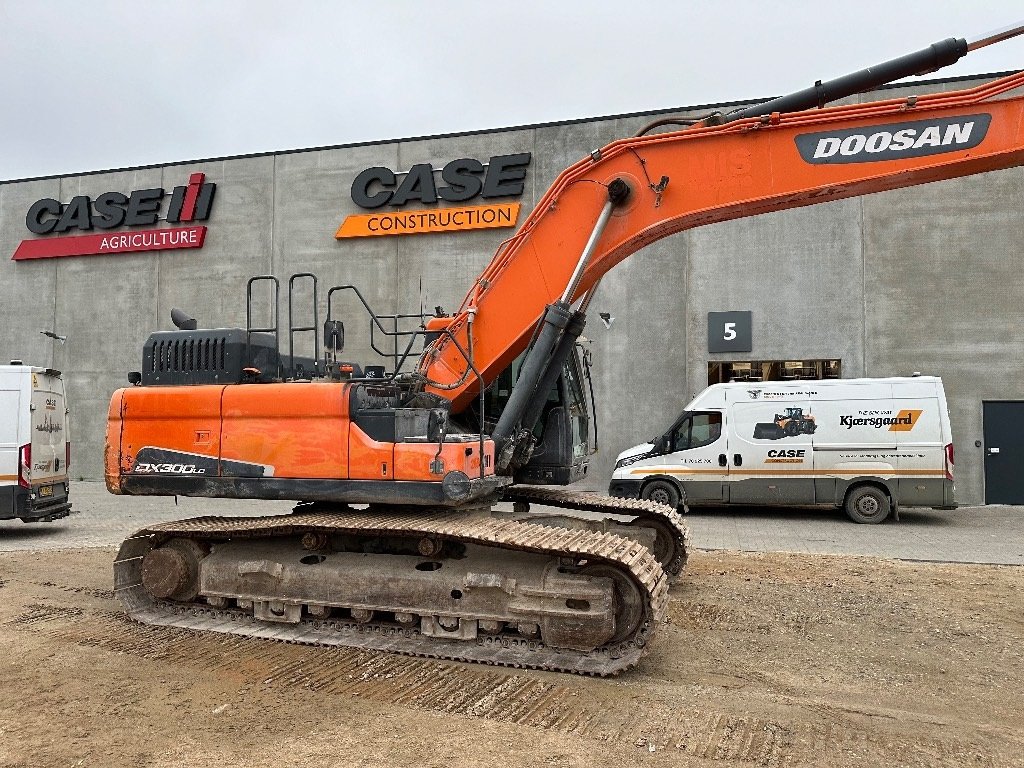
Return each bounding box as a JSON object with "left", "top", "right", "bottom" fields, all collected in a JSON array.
[{"left": 114, "top": 489, "right": 686, "bottom": 676}]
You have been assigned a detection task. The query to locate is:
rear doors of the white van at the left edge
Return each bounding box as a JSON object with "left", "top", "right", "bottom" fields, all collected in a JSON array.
[{"left": 27, "top": 371, "right": 69, "bottom": 502}]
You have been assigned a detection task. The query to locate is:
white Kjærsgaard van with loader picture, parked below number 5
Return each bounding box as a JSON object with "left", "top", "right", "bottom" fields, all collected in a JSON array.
[{"left": 609, "top": 376, "right": 955, "bottom": 522}]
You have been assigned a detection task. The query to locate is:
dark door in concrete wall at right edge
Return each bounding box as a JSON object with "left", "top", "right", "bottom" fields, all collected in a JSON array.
[{"left": 982, "top": 400, "right": 1024, "bottom": 504}]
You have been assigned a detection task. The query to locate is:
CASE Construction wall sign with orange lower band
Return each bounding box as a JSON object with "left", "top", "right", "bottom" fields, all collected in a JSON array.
[{"left": 334, "top": 153, "right": 530, "bottom": 240}]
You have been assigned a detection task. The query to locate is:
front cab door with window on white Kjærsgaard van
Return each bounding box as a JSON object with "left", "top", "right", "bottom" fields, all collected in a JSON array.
[{"left": 644, "top": 411, "right": 729, "bottom": 502}]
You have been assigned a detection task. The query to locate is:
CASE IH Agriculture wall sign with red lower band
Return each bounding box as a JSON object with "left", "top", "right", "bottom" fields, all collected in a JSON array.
[{"left": 12, "top": 173, "right": 217, "bottom": 261}]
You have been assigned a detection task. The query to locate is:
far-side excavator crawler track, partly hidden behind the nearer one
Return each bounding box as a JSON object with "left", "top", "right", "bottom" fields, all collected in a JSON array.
[{"left": 502, "top": 485, "right": 690, "bottom": 582}]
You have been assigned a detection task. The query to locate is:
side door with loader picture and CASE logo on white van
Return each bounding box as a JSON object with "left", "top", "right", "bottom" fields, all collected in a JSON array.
[{"left": 728, "top": 399, "right": 817, "bottom": 504}]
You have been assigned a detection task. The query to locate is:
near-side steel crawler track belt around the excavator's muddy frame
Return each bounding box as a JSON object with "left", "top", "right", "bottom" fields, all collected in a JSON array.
[{"left": 114, "top": 505, "right": 669, "bottom": 676}]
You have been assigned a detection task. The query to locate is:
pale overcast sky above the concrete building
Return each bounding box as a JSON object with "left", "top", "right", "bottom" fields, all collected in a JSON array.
[{"left": 0, "top": 0, "right": 1024, "bottom": 180}]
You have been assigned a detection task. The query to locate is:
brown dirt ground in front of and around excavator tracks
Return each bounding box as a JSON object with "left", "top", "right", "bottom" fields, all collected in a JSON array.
[{"left": 0, "top": 549, "right": 1024, "bottom": 768}]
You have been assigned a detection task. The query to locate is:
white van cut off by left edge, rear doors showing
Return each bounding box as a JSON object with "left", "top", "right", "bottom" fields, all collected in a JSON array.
[{"left": 0, "top": 360, "right": 71, "bottom": 522}]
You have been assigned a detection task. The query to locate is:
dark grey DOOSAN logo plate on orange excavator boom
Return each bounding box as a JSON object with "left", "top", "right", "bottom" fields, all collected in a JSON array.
[{"left": 796, "top": 114, "right": 992, "bottom": 165}]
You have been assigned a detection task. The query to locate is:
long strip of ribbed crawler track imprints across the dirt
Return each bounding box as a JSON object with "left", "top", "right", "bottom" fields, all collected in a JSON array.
[{"left": 7, "top": 602, "right": 990, "bottom": 768}]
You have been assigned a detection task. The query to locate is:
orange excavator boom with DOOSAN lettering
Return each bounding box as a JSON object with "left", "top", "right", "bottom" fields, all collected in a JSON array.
[{"left": 420, "top": 55, "right": 1024, "bottom": 421}]
